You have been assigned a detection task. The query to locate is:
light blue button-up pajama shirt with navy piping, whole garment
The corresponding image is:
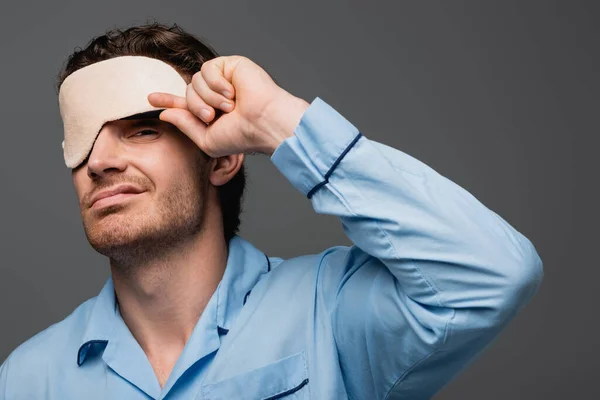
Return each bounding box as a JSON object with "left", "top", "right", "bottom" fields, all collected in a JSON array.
[{"left": 0, "top": 97, "right": 543, "bottom": 400}]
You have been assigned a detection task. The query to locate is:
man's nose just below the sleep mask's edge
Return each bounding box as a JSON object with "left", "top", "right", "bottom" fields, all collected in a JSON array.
[{"left": 87, "top": 125, "right": 127, "bottom": 179}]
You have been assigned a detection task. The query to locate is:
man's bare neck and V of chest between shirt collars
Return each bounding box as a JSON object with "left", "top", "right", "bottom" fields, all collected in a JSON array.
[{"left": 111, "top": 217, "right": 228, "bottom": 365}]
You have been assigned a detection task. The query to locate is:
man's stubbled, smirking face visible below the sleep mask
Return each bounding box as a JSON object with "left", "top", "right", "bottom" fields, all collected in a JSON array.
[{"left": 72, "top": 118, "right": 210, "bottom": 262}]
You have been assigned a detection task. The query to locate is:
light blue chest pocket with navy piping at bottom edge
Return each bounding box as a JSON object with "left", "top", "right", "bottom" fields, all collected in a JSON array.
[{"left": 202, "top": 352, "right": 309, "bottom": 400}]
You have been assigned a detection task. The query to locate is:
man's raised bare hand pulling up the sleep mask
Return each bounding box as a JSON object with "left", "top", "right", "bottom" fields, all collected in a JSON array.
[{"left": 148, "top": 56, "right": 309, "bottom": 157}]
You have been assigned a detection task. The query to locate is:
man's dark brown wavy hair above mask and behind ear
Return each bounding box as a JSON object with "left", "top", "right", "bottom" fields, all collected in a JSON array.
[{"left": 56, "top": 22, "right": 246, "bottom": 243}]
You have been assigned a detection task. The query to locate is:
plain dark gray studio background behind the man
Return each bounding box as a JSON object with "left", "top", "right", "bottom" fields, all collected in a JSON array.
[{"left": 0, "top": 0, "right": 600, "bottom": 400}]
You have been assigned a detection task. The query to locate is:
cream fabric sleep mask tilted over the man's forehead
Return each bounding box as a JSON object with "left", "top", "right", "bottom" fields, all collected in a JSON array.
[{"left": 58, "top": 56, "right": 187, "bottom": 168}]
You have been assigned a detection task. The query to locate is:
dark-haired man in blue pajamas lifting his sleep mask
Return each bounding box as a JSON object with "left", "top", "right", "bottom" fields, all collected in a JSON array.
[{"left": 0, "top": 24, "right": 543, "bottom": 399}]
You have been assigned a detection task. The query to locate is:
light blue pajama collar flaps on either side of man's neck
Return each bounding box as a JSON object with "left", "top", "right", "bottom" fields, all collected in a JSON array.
[{"left": 77, "top": 235, "right": 271, "bottom": 365}]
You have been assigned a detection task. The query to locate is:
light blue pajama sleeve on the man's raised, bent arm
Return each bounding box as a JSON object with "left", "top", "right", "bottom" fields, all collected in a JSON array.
[{"left": 271, "top": 97, "right": 543, "bottom": 399}]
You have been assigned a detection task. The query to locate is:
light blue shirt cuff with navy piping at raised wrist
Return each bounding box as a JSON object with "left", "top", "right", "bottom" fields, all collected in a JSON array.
[{"left": 271, "top": 97, "right": 362, "bottom": 198}]
